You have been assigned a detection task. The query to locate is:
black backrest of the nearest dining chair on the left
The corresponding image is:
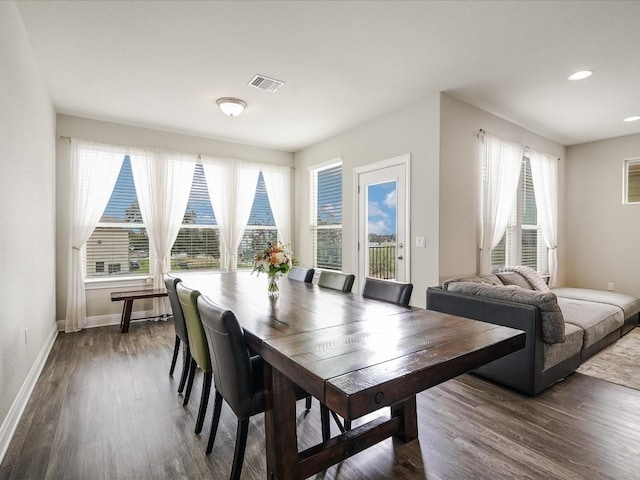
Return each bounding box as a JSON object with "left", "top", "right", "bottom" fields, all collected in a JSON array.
[{"left": 198, "top": 295, "right": 257, "bottom": 418}]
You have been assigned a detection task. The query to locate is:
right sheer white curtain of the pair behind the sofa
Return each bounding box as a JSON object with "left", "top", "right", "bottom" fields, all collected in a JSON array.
[{"left": 529, "top": 150, "right": 558, "bottom": 288}]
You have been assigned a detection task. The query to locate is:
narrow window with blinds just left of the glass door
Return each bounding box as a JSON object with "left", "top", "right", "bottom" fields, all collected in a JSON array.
[{"left": 310, "top": 162, "right": 342, "bottom": 270}]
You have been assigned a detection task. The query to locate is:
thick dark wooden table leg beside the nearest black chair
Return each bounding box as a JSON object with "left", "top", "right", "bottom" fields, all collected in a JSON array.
[{"left": 264, "top": 362, "right": 299, "bottom": 480}]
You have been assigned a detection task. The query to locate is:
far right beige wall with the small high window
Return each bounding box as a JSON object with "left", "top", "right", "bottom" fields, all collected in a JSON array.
[{"left": 565, "top": 134, "right": 640, "bottom": 297}]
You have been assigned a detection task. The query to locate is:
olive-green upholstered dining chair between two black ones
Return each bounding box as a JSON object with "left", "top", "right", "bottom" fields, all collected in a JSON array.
[{"left": 176, "top": 283, "right": 212, "bottom": 433}]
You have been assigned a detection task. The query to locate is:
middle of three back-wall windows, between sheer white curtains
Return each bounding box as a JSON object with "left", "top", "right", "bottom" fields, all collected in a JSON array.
[{"left": 171, "top": 164, "right": 220, "bottom": 271}]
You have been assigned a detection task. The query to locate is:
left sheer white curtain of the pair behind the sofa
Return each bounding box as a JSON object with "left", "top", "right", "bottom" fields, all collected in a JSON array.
[{"left": 480, "top": 133, "right": 524, "bottom": 275}]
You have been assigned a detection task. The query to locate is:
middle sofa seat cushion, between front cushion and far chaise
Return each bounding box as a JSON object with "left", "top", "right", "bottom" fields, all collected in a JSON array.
[{"left": 558, "top": 298, "right": 624, "bottom": 348}]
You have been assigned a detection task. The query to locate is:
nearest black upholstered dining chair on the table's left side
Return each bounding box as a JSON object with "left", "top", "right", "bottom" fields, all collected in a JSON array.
[{"left": 198, "top": 295, "right": 328, "bottom": 480}]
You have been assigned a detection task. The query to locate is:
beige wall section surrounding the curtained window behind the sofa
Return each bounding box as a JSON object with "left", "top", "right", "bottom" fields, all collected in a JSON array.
[{"left": 439, "top": 94, "right": 571, "bottom": 285}]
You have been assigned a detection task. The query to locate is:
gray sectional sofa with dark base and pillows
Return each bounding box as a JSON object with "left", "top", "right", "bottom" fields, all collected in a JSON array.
[{"left": 427, "top": 267, "right": 640, "bottom": 395}]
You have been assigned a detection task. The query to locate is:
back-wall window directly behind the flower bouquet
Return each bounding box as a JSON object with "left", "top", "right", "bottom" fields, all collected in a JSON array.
[{"left": 238, "top": 172, "right": 278, "bottom": 268}]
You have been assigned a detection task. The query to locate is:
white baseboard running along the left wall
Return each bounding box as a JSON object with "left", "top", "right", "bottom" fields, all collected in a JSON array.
[{"left": 0, "top": 324, "right": 58, "bottom": 463}]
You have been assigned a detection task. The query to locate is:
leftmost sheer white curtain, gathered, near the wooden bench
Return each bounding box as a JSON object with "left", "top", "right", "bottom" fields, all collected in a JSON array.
[{"left": 65, "top": 139, "right": 126, "bottom": 332}]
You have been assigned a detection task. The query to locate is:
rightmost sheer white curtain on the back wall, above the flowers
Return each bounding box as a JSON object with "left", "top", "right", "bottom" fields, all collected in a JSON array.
[{"left": 262, "top": 165, "right": 291, "bottom": 246}]
